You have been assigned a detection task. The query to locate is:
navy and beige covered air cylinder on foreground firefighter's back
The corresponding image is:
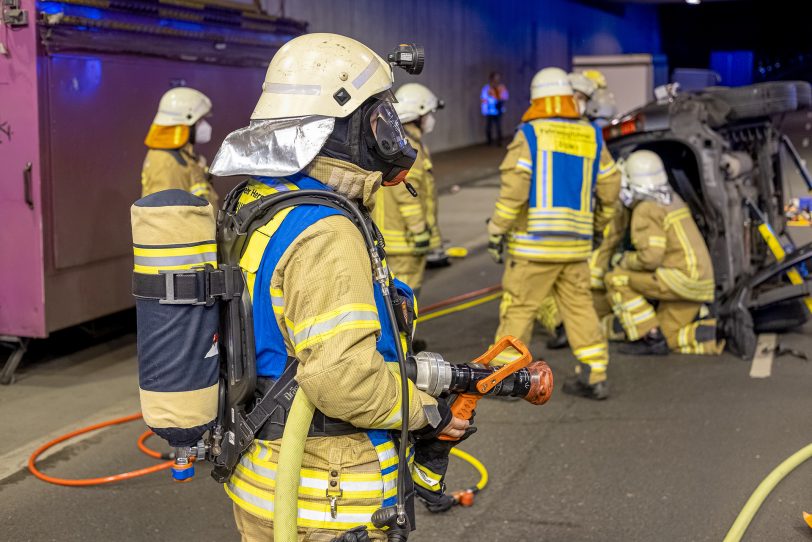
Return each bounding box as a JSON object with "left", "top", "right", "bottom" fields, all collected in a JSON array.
[{"left": 131, "top": 190, "right": 220, "bottom": 479}]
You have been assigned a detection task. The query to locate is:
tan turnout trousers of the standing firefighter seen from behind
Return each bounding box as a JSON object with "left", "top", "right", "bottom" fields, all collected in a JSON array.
[{"left": 496, "top": 258, "right": 609, "bottom": 384}]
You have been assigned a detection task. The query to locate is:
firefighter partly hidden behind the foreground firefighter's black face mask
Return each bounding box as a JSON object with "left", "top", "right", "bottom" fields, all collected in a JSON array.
[{"left": 373, "top": 83, "right": 442, "bottom": 295}]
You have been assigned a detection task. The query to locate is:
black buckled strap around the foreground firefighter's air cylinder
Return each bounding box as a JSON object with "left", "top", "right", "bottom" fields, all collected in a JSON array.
[{"left": 133, "top": 264, "right": 242, "bottom": 306}]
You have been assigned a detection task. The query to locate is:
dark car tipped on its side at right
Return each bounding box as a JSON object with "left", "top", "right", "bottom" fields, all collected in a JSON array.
[{"left": 604, "top": 82, "right": 812, "bottom": 359}]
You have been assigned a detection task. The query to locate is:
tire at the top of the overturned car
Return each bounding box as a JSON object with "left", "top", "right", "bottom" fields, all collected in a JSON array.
[{"left": 706, "top": 81, "right": 806, "bottom": 120}]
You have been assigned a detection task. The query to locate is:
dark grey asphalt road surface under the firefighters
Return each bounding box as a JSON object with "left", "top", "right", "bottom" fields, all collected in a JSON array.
[{"left": 0, "top": 155, "right": 812, "bottom": 542}]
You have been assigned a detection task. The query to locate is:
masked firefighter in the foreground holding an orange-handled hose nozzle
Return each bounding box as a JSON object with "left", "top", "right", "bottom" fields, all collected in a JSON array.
[{"left": 205, "top": 34, "right": 468, "bottom": 542}]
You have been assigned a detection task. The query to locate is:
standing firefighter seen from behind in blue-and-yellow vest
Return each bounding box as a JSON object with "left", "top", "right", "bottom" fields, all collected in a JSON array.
[{"left": 488, "top": 68, "right": 620, "bottom": 399}]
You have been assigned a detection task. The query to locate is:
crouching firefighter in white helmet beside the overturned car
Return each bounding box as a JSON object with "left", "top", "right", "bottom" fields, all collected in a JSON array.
[{"left": 604, "top": 150, "right": 724, "bottom": 355}]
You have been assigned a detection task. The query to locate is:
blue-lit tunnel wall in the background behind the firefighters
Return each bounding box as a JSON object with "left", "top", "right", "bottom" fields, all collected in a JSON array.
[{"left": 264, "top": 0, "right": 660, "bottom": 151}]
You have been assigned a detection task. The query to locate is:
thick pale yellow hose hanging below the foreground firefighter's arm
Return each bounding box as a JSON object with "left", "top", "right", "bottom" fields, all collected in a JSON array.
[{"left": 274, "top": 389, "right": 316, "bottom": 542}]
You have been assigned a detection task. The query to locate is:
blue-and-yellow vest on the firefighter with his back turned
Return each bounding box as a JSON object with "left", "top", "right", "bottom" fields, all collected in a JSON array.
[{"left": 520, "top": 119, "right": 603, "bottom": 240}]
